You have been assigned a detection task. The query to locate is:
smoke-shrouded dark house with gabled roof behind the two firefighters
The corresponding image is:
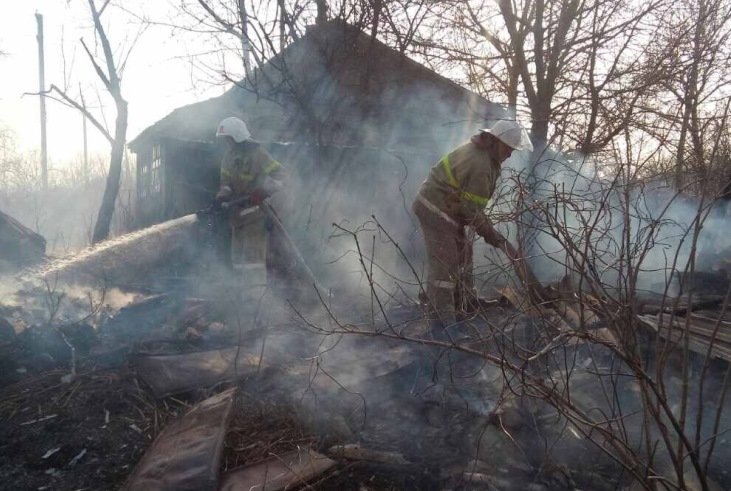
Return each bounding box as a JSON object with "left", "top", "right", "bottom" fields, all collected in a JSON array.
[{"left": 129, "top": 21, "right": 505, "bottom": 276}]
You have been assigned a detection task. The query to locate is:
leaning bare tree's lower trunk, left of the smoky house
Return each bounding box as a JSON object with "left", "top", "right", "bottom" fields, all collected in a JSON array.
[{"left": 91, "top": 98, "right": 127, "bottom": 244}]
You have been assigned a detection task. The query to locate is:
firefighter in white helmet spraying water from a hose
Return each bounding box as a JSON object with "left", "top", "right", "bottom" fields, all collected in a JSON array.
[{"left": 216, "top": 117, "right": 283, "bottom": 291}]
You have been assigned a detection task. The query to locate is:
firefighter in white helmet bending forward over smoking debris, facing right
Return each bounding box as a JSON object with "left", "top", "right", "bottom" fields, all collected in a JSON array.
[{"left": 413, "top": 120, "right": 533, "bottom": 337}]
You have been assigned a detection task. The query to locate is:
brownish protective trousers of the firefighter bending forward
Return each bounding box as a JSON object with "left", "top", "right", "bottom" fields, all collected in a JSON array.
[{"left": 413, "top": 199, "right": 473, "bottom": 336}]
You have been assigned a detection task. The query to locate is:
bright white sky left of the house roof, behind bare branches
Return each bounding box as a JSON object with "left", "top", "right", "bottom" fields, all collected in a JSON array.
[{"left": 0, "top": 0, "right": 225, "bottom": 167}]
